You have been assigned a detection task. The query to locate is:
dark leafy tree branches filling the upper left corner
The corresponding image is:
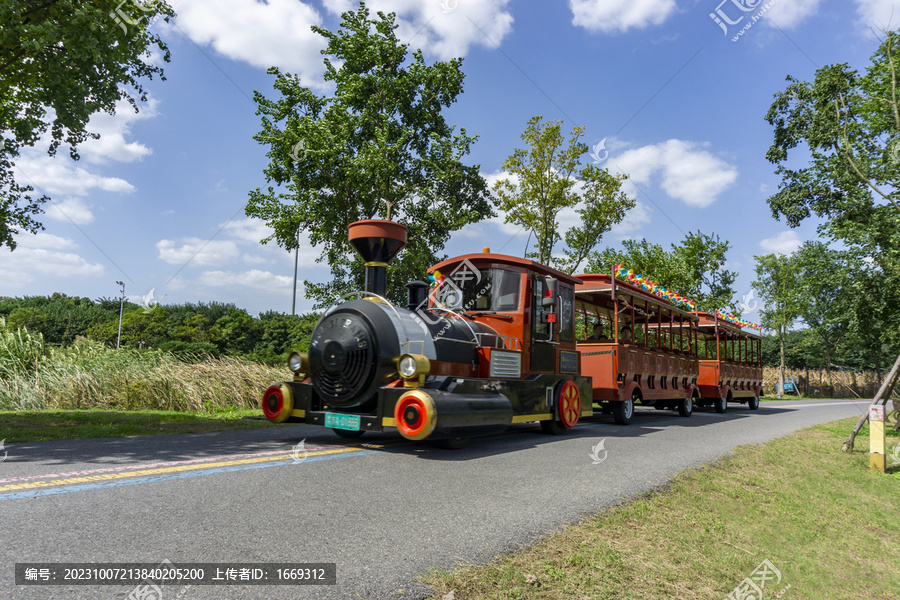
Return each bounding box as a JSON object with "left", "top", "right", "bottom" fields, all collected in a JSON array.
[{"left": 0, "top": 0, "right": 175, "bottom": 250}]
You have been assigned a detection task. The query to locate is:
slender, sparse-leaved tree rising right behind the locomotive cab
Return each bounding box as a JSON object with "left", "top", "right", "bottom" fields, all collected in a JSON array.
[{"left": 494, "top": 117, "right": 634, "bottom": 273}]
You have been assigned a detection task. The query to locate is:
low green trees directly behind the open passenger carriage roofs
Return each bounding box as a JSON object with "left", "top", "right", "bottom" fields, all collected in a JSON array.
[{"left": 587, "top": 231, "right": 740, "bottom": 314}]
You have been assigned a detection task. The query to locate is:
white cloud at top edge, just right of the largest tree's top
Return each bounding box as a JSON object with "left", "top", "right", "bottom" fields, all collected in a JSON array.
[{"left": 323, "top": 0, "right": 513, "bottom": 60}]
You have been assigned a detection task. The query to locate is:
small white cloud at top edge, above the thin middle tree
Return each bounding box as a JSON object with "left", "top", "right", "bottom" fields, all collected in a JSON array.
[{"left": 569, "top": 0, "right": 677, "bottom": 33}]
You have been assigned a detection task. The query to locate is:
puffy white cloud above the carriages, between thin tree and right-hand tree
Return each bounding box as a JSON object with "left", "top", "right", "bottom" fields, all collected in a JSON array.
[{"left": 609, "top": 139, "right": 738, "bottom": 208}]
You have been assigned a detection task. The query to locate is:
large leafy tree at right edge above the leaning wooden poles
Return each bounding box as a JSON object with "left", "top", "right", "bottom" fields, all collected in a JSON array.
[{"left": 766, "top": 31, "right": 900, "bottom": 350}]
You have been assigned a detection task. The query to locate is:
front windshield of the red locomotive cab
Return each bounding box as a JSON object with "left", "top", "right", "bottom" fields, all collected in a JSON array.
[{"left": 432, "top": 268, "right": 521, "bottom": 312}]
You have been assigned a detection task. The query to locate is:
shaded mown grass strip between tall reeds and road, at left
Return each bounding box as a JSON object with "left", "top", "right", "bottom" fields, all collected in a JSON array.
[{"left": 0, "top": 409, "right": 288, "bottom": 443}]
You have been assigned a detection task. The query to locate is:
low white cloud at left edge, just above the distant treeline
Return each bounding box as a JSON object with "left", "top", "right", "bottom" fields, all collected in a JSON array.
[{"left": 0, "top": 233, "right": 104, "bottom": 287}]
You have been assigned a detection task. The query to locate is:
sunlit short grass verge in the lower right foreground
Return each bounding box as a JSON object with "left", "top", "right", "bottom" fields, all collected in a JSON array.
[{"left": 425, "top": 419, "right": 900, "bottom": 600}]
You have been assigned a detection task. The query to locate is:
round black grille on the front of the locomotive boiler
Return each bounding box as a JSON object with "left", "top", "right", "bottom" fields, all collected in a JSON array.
[{"left": 309, "top": 312, "right": 377, "bottom": 406}]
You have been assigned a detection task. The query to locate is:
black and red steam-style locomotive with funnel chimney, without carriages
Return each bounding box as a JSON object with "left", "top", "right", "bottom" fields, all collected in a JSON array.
[{"left": 262, "top": 220, "right": 593, "bottom": 446}]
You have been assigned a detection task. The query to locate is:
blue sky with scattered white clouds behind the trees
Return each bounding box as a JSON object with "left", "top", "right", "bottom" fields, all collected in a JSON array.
[{"left": 0, "top": 0, "right": 900, "bottom": 322}]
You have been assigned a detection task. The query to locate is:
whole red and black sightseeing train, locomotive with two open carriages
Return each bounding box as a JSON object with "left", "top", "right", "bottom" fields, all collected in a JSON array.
[{"left": 261, "top": 219, "right": 762, "bottom": 447}]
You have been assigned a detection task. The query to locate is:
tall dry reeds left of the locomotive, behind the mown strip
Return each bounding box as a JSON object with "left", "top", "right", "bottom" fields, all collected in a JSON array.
[{"left": 0, "top": 321, "right": 288, "bottom": 412}]
